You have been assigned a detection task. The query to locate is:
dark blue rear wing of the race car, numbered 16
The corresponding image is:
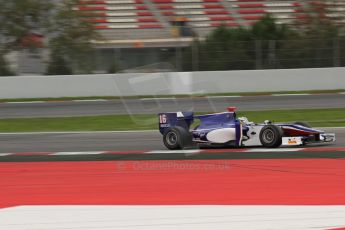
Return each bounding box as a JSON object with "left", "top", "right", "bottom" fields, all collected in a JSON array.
[{"left": 158, "top": 112, "right": 194, "bottom": 134}]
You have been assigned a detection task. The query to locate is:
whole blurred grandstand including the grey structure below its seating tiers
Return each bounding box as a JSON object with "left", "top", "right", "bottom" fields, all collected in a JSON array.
[{"left": 75, "top": 0, "right": 345, "bottom": 71}]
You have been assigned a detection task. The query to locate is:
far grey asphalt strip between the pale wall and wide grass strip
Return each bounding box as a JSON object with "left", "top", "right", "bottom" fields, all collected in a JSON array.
[{"left": 0, "top": 94, "right": 345, "bottom": 118}]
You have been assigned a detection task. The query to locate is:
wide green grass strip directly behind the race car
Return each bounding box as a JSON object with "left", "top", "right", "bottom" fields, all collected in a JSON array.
[{"left": 0, "top": 108, "right": 345, "bottom": 132}]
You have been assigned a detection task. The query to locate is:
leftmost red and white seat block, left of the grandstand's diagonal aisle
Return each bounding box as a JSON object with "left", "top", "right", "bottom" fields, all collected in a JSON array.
[{"left": 76, "top": 0, "right": 173, "bottom": 40}]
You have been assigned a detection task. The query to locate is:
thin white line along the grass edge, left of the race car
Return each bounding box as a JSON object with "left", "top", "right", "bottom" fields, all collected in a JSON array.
[{"left": 0, "top": 130, "right": 158, "bottom": 135}]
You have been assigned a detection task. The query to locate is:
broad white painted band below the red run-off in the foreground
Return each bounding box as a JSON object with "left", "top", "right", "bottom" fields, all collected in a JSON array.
[{"left": 0, "top": 205, "right": 345, "bottom": 230}]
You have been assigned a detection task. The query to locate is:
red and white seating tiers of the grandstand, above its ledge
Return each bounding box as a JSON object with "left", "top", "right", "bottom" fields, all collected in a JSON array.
[{"left": 76, "top": 0, "right": 345, "bottom": 41}]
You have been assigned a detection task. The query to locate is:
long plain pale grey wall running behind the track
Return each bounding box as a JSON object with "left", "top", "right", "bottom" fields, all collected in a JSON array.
[{"left": 0, "top": 68, "right": 345, "bottom": 99}]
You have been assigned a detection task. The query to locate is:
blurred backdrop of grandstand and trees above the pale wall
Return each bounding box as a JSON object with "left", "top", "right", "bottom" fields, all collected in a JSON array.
[{"left": 0, "top": 0, "right": 345, "bottom": 76}]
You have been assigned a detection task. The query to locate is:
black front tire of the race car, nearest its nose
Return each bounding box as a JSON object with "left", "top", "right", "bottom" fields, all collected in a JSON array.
[{"left": 259, "top": 125, "right": 283, "bottom": 148}]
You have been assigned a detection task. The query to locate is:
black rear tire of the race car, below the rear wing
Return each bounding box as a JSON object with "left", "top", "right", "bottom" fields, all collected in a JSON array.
[{"left": 163, "top": 126, "right": 192, "bottom": 150}]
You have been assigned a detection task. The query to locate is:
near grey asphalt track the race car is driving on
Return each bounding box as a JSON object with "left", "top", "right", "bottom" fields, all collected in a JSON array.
[{"left": 0, "top": 128, "right": 345, "bottom": 153}]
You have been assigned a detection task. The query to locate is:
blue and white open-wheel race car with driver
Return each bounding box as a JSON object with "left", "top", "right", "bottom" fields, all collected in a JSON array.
[{"left": 158, "top": 107, "right": 335, "bottom": 150}]
